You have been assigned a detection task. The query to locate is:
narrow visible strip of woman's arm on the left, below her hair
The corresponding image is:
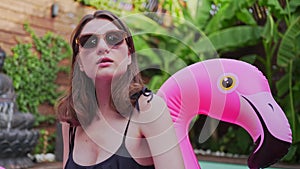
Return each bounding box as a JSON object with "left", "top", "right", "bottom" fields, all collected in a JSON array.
[{"left": 61, "top": 122, "right": 70, "bottom": 168}]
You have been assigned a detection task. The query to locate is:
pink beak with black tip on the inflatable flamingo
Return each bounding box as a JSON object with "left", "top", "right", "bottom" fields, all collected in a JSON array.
[{"left": 242, "top": 92, "right": 292, "bottom": 169}]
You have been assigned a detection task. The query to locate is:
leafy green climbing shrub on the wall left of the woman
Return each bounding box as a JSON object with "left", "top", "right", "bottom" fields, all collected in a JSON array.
[{"left": 4, "top": 24, "right": 71, "bottom": 125}]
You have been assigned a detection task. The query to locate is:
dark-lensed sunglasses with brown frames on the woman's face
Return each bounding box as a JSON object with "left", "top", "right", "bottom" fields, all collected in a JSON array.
[{"left": 76, "top": 30, "right": 127, "bottom": 49}]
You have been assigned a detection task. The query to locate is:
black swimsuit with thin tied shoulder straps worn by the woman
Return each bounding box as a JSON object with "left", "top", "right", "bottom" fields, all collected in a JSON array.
[{"left": 65, "top": 89, "right": 155, "bottom": 169}]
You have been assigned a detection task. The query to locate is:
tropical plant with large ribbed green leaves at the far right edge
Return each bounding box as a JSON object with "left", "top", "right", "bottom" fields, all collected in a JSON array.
[{"left": 276, "top": 16, "right": 300, "bottom": 162}]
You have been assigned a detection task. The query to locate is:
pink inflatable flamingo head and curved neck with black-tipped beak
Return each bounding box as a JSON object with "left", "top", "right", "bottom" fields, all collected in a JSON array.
[{"left": 157, "top": 59, "right": 292, "bottom": 169}]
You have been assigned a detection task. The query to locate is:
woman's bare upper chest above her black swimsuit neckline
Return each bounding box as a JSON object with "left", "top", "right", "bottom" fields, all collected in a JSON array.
[{"left": 73, "top": 123, "right": 151, "bottom": 165}]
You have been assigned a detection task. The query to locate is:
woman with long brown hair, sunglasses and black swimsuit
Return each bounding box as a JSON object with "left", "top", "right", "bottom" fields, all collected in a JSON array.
[{"left": 57, "top": 11, "right": 184, "bottom": 169}]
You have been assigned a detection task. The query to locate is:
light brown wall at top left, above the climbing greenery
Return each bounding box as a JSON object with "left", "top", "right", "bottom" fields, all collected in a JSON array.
[{"left": 0, "top": 0, "right": 93, "bottom": 55}]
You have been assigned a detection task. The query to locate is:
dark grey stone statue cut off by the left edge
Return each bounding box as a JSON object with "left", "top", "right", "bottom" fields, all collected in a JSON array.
[{"left": 0, "top": 48, "right": 39, "bottom": 169}]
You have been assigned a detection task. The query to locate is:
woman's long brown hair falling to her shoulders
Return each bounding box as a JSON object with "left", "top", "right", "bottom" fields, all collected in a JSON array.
[{"left": 56, "top": 10, "right": 143, "bottom": 126}]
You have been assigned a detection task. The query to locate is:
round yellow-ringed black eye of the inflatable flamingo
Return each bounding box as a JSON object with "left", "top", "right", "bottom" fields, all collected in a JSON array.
[{"left": 218, "top": 74, "right": 238, "bottom": 93}]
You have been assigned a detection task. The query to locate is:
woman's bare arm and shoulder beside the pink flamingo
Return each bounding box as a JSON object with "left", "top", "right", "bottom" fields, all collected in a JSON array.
[{"left": 140, "top": 96, "right": 184, "bottom": 169}]
